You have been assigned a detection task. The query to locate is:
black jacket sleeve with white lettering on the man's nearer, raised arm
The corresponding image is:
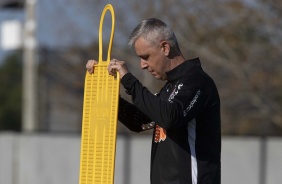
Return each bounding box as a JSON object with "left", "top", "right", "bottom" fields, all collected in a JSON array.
[{"left": 121, "top": 73, "right": 207, "bottom": 130}]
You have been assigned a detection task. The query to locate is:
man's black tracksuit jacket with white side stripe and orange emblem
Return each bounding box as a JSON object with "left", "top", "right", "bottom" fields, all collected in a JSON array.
[{"left": 118, "top": 58, "right": 221, "bottom": 184}]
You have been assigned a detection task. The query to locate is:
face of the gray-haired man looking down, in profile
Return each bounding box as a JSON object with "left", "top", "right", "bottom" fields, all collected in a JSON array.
[{"left": 134, "top": 37, "right": 169, "bottom": 80}]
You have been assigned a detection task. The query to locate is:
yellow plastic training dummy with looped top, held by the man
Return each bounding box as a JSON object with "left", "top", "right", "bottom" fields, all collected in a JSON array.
[{"left": 79, "top": 4, "right": 120, "bottom": 184}]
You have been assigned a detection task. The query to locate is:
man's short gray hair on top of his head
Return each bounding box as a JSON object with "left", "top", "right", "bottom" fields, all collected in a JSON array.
[{"left": 128, "top": 18, "right": 179, "bottom": 50}]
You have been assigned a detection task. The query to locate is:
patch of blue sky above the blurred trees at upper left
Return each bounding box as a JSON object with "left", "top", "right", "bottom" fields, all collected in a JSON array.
[{"left": 0, "top": 0, "right": 135, "bottom": 63}]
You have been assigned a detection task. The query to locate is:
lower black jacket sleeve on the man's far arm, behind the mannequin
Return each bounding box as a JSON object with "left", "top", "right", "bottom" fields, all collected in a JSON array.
[{"left": 118, "top": 97, "right": 154, "bottom": 132}]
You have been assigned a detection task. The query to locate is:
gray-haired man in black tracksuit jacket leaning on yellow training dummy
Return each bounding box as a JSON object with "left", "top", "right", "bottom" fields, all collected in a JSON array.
[{"left": 86, "top": 18, "right": 221, "bottom": 184}]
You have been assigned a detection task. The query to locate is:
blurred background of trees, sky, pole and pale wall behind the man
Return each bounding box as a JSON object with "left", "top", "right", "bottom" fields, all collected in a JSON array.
[{"left": 0, "top": 0, "right": 282, "bottom": 184}]
